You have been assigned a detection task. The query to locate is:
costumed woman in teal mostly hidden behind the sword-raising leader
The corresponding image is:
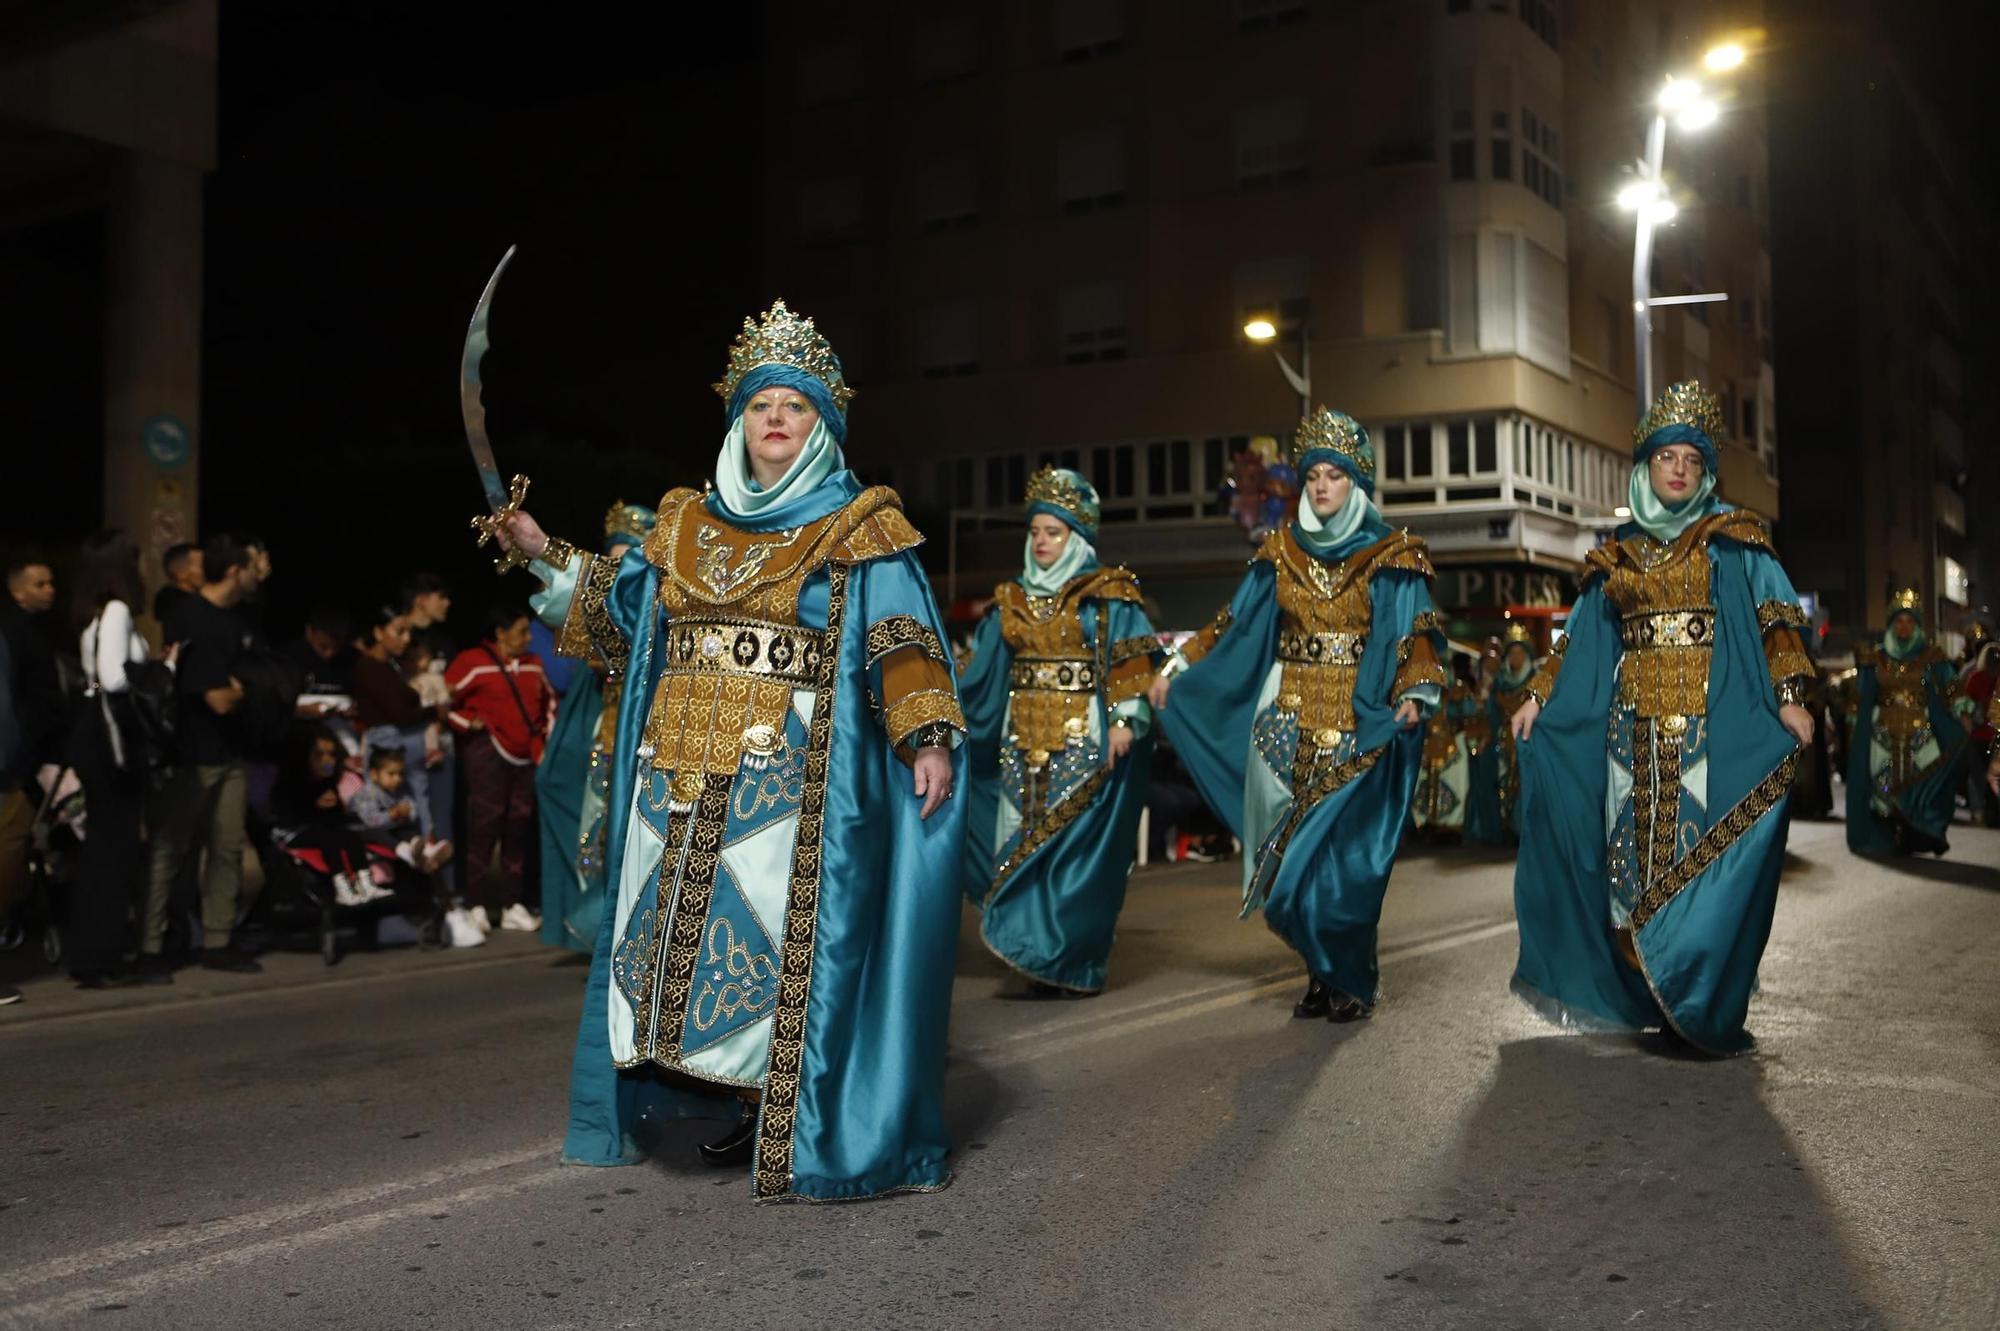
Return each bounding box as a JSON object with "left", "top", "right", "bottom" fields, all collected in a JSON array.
[{"left": 534, "top": 500, "right": 656, "bottom": 953}]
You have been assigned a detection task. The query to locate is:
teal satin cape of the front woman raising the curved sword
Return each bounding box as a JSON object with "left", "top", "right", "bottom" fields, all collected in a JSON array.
[{"left": 562, "top": 472, "right": 964, "bottom": 1201}]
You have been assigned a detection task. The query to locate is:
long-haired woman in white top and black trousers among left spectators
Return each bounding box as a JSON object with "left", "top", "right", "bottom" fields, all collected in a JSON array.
[{"left": 66, "top": 532, "right": 174, "bottom": 989}]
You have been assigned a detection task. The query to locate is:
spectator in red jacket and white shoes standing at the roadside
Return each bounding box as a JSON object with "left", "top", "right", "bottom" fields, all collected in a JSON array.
[{"left": 444, "top": 606, "right": 556, "bottom": 933}]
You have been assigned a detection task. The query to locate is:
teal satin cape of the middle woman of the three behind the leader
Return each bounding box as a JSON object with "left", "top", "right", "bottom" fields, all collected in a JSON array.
[{"left": 1160, "top": 520, "right": 1446, "bottom": 1001}]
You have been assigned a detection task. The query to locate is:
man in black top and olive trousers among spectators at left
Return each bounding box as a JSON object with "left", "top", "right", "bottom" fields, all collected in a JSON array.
[{"left": 140, "top": 536, "right": 266, "bottom": 973}]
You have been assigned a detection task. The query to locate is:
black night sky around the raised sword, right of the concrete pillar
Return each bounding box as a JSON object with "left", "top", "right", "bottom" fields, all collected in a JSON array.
[{"left": 202, "top": 0, "right": 764, "bottom": 636}]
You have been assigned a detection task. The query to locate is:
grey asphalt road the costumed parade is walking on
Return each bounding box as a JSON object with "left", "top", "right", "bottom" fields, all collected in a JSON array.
[{"left": 0, "top": 823, "right": 2000, "bottom": 1331}]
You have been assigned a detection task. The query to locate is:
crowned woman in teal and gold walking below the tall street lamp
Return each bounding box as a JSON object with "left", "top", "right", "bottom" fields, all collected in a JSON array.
[{"left": 1512, "top": 382, "right": 1812, "bottom": 1053}]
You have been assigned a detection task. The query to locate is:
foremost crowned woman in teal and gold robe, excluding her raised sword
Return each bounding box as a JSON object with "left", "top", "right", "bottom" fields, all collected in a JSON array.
[{"left": 504, "top": 302, "right": 964, "bottom": 1201}]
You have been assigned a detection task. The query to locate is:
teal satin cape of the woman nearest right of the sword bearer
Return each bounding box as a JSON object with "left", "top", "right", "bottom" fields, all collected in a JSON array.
[{"left": 958, "top": 587, "right": 1154, "bottom": 993}]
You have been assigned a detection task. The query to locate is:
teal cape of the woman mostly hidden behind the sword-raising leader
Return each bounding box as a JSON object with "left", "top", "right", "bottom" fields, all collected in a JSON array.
[{"left": 534, "top": 664, "right": 604, "bottom": 951}]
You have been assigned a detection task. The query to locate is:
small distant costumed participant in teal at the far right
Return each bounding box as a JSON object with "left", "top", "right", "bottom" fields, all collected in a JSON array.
[{"left": 1846, "top": 588, "right": 1972, "bottom": 855}]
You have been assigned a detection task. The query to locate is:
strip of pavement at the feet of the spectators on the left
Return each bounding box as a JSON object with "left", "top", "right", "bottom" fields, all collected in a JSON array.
[{"left": 0, "top": 929, "right": 568, "bottom": 1037}]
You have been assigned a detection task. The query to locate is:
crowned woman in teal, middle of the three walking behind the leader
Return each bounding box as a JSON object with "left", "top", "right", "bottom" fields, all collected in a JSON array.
[{"left": 1150, "top": 408, "right": 1446, "bottom": 1021}]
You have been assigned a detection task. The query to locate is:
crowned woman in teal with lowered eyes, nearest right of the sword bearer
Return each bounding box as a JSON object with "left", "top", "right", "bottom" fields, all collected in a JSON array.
[{"left": 958, "top": 468, "right": 1164, "bottom": 983}]
